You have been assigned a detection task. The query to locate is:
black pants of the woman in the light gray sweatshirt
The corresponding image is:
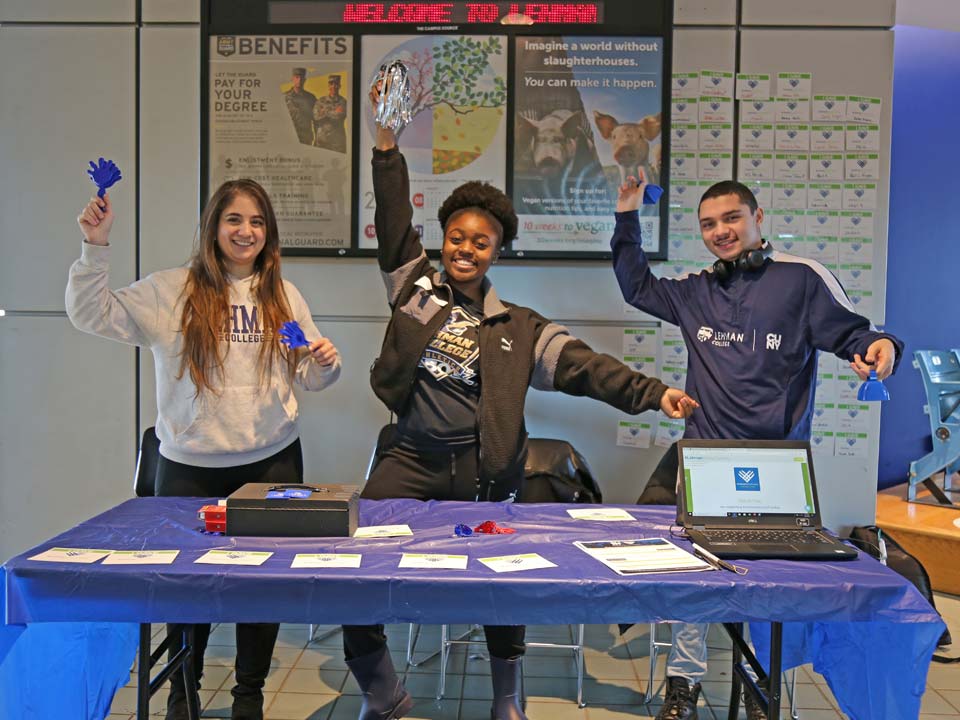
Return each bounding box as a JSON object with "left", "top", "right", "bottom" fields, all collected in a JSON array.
[{"left": 156, "top": 439, "right": 303, "bottom": 704}]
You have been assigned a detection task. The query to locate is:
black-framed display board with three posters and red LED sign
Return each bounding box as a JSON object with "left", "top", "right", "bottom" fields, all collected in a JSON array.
[{"left": 200, "top": 0, "right": 673, "bottom": 260}]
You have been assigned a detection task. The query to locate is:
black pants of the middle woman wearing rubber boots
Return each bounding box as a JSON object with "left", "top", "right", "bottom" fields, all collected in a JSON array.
[{"left": 343, "top": 440, "right": 526, "bottom": 660}]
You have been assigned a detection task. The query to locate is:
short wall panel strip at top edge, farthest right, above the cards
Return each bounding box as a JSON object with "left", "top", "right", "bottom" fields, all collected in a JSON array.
[{"left": 742, "top": 0, "right": 892, "bottom": 27}]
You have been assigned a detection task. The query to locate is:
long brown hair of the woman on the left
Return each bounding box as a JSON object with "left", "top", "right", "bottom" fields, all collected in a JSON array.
[{"left": 177, "top": 179, "right": 297, "bottom": 396}]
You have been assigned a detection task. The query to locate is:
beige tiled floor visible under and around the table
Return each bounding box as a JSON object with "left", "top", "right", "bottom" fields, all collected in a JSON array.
[{"left": 109, "top": 596, "right": 960, "bottom": 720}]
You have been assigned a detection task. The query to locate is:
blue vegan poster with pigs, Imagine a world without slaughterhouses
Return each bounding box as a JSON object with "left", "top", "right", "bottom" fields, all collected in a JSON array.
[{"left": 513, "top": 36, "right": 663, "bottom": 252}]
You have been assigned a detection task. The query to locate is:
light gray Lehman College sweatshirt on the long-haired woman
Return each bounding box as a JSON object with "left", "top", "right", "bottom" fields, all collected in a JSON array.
[{"left": 66, "top": 242, "right": 340, "bottom": 467}]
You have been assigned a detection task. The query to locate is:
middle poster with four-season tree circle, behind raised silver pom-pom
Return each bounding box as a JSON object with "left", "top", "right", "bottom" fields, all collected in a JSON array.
[{"left": 357, "top": 35, "right": 507, "bottom": 249}]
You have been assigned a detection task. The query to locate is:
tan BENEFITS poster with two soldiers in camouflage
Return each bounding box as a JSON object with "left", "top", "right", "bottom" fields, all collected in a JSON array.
[{"left": 208, "top": 35, "right": 356, "bottom": 254}]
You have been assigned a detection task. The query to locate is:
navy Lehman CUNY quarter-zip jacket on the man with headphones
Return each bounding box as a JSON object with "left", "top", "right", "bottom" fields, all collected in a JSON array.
[{"left": 610, "top": 211, "right": 903, "bottom": 440}]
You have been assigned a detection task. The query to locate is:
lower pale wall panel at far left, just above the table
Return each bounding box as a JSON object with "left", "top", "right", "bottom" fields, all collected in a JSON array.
[{"left": 0, "top": 316, "right": 136, "bottom": 561}]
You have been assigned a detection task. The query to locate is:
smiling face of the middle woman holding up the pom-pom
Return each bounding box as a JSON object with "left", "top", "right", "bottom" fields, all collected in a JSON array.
[{"left": 440, "top": 208, "right": 501, "bottom": 293}]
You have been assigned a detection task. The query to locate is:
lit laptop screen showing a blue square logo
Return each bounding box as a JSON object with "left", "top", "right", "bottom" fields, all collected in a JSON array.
[{"left": 680, "top": 442, "right": 817, "bottom": 519}]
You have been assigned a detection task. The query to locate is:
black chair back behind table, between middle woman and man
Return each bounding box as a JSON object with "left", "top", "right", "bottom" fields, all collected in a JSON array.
[{"left": 520, "top": 438, "right": 603, "bottom": 503}]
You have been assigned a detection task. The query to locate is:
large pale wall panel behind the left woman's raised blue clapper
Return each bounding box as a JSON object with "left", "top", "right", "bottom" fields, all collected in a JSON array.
[{"left": 0, "top": 26, "right": 137, "bottom": 310}]
